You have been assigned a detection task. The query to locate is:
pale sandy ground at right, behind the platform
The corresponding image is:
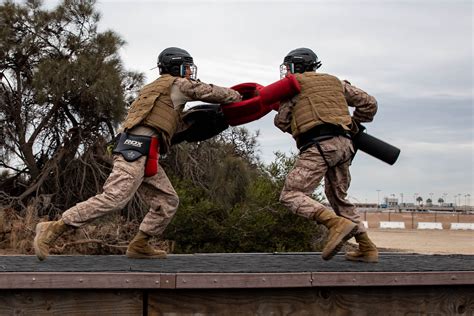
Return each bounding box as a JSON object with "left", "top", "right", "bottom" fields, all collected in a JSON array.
[{"left": 368, "top": 229, "right": 474, "bottom": 255}]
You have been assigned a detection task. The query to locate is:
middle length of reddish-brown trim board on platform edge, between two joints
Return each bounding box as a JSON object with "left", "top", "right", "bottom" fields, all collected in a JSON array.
[{"left": 176, "top": 272, "right": 311, "bottom": 289}]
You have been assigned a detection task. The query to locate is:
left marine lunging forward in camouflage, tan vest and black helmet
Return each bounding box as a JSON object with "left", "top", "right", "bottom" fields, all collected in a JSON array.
[{"left": 34, "top": 47, "right": 241, "bottom": 260}]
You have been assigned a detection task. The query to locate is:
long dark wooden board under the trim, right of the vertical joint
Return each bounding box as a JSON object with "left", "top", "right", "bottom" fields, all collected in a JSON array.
[{"left": 148, "top": 286, "right": 474, "bottom": 315}]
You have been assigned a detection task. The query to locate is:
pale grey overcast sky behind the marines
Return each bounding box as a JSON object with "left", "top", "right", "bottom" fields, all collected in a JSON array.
[{"left": 39, "top": 0, "right": 474, "bottom": 205}]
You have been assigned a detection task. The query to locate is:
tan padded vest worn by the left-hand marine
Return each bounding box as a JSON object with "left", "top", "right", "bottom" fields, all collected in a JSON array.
[{"left": 122, "top": 75, "right": 179, "bottom": 141}]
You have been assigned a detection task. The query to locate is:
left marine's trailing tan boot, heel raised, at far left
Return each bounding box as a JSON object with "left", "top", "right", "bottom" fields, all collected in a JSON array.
[{"left": 33, "top": 219, "right": 72, "bottom": 261}]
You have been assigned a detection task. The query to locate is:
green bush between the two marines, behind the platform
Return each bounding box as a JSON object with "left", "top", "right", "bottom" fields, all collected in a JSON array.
[{"left": 164, "top": 129, "right": 325, "bottom": 253}]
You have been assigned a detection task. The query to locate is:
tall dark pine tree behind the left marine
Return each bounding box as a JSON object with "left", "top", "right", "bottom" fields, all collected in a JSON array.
[{"left": 0, "top": 0, "right": 143, "bottom": 207}]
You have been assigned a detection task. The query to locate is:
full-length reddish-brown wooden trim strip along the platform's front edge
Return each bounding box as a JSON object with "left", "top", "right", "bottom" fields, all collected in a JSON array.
[{"left": 0, "top": 271, "right": 474, "bottom": 289}]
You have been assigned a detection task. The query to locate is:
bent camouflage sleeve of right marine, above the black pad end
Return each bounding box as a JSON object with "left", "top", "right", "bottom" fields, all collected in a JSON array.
[{"left": 342, "top": 80, "right": 377, "bottom": 123}]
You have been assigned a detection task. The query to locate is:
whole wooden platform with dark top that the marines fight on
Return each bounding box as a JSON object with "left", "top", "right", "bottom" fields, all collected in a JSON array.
[{"left": 0, "top": 253, "right": 474, "bottom": 315}]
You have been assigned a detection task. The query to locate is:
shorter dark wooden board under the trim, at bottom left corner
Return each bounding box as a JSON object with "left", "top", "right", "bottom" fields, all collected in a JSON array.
[{"left": 0, "top": 290, "right": 143, "bottom": 316}]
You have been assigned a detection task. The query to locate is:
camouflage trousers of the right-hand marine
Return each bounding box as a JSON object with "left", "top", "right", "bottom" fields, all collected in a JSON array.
[{"left": 280, "top": 136, "right": 366, "bottom": 232}]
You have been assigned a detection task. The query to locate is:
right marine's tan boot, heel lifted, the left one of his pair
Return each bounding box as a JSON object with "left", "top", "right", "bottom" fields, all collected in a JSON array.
[{"left": 314, "top": 209, "right": 357, "bottom": 260}]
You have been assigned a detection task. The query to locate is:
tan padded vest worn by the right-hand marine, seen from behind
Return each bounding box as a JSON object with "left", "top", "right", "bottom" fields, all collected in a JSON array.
[{"left": 291, "top": 72, "right": 351, "bottom": 138}]
